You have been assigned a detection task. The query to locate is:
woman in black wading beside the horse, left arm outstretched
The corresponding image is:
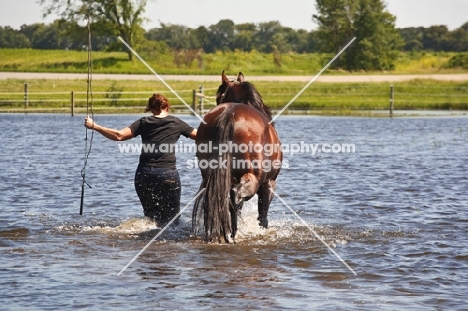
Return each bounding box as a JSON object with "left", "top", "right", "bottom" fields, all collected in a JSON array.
[{"left": 85, "top": 94, "right": 197, "bottom": 227}]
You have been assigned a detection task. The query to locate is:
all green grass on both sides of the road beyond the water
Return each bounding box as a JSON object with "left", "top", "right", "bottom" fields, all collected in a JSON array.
[{"left": 0, "top": 49, "right": 468, "bottom": 114}]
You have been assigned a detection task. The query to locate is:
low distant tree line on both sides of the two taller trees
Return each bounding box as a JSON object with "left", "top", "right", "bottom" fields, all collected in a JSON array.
[{"left": 0, "top": 20, "right": 468, "bottom": 53}]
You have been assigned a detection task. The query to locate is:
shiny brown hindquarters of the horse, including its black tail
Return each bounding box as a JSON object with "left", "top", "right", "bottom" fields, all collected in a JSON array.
[{"left": 193, "top": 103, "right": 281, "bottom": 241}]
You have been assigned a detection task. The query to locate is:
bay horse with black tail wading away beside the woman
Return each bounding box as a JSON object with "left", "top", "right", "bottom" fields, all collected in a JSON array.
[{"left": 192, "top": 71, "right": 283, "bottom": 243}]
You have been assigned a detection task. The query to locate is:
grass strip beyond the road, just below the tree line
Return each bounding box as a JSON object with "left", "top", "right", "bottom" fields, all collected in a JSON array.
[{"left": 0, "top": 49, "right": 467, "bottom": 75}]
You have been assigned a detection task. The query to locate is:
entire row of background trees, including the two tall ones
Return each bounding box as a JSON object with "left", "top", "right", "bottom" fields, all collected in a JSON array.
[{"left": 0, "top": 0, "right": 468, "bottom": 70}]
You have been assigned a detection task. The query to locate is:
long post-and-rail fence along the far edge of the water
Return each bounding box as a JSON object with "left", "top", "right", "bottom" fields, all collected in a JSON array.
[{"left": 0, "top": 83, "right": 468, "bottom": 115}]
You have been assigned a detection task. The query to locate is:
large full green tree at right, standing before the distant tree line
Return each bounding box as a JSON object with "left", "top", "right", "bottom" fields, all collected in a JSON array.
[{"left": 313, "top": 0, "right": 402, "bottom": 70}]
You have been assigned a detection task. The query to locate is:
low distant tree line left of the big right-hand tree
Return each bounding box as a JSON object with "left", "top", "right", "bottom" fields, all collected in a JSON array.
[{"left": 0, "top": 20, "right": 319, "bottom": 53}]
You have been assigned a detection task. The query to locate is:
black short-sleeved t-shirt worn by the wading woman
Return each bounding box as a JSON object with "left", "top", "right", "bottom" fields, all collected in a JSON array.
[{"left": 129, "top": 116, "right": 193, "bottom": 168}]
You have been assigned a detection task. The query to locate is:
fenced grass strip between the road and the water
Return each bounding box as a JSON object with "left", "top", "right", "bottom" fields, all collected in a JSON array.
[{"left": 0, "top": 79, "right": 468, "bottom": 115}]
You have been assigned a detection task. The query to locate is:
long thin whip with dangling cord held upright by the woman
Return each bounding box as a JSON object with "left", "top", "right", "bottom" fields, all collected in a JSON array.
[{"left": 80, "top": 13, "right": 94, "bottom": 215}]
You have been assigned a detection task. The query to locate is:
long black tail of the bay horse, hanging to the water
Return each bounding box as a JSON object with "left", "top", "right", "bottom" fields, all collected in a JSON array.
[{"left": 192, "top": 109, "right": 234, "bottom": 242}]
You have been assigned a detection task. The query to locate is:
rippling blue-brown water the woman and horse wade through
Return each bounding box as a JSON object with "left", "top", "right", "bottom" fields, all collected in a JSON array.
[{"left": 0, "top": 114, "right": 468, "bottom": 310}]
